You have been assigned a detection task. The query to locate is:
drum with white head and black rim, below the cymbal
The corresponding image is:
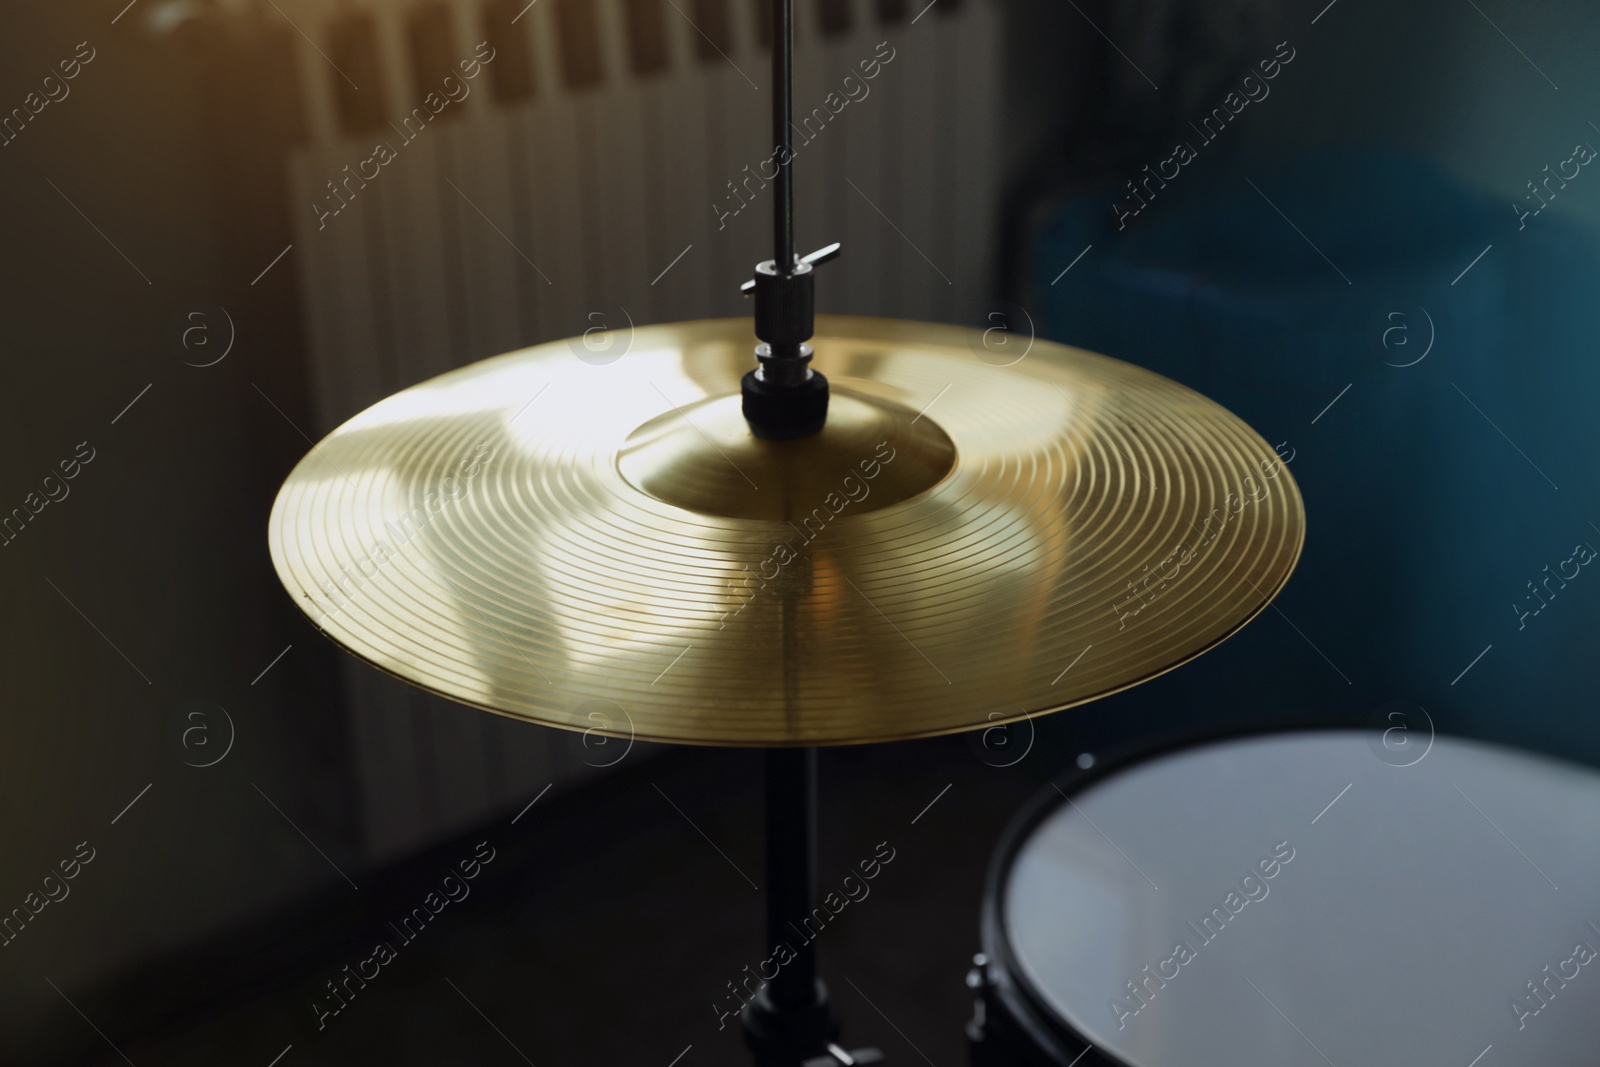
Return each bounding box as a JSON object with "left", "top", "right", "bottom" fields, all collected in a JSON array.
[{"left": 968, "top": 729, "right": 1600, "bottom": 1067}]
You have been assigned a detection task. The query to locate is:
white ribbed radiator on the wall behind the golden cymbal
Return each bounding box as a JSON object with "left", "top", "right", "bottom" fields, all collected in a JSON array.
[{"left": 275, "top": 0, "right": 1002, "bottom": 859}]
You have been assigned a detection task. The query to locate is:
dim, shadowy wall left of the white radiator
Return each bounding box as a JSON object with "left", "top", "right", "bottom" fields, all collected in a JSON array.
[{"left": 0, "top": 0, "right": 349, "bottom": 1032}]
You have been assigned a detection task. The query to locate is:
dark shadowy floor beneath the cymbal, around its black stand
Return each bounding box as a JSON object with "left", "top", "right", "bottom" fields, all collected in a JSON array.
[{"left": 27, "top": 737, "right": 1061, "bottom": 1067}]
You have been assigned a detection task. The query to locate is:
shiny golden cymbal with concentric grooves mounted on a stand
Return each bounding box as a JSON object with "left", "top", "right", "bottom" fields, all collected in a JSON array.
[{"left": 270, "top": 317, "right": 1306, "bottom": 747}]
